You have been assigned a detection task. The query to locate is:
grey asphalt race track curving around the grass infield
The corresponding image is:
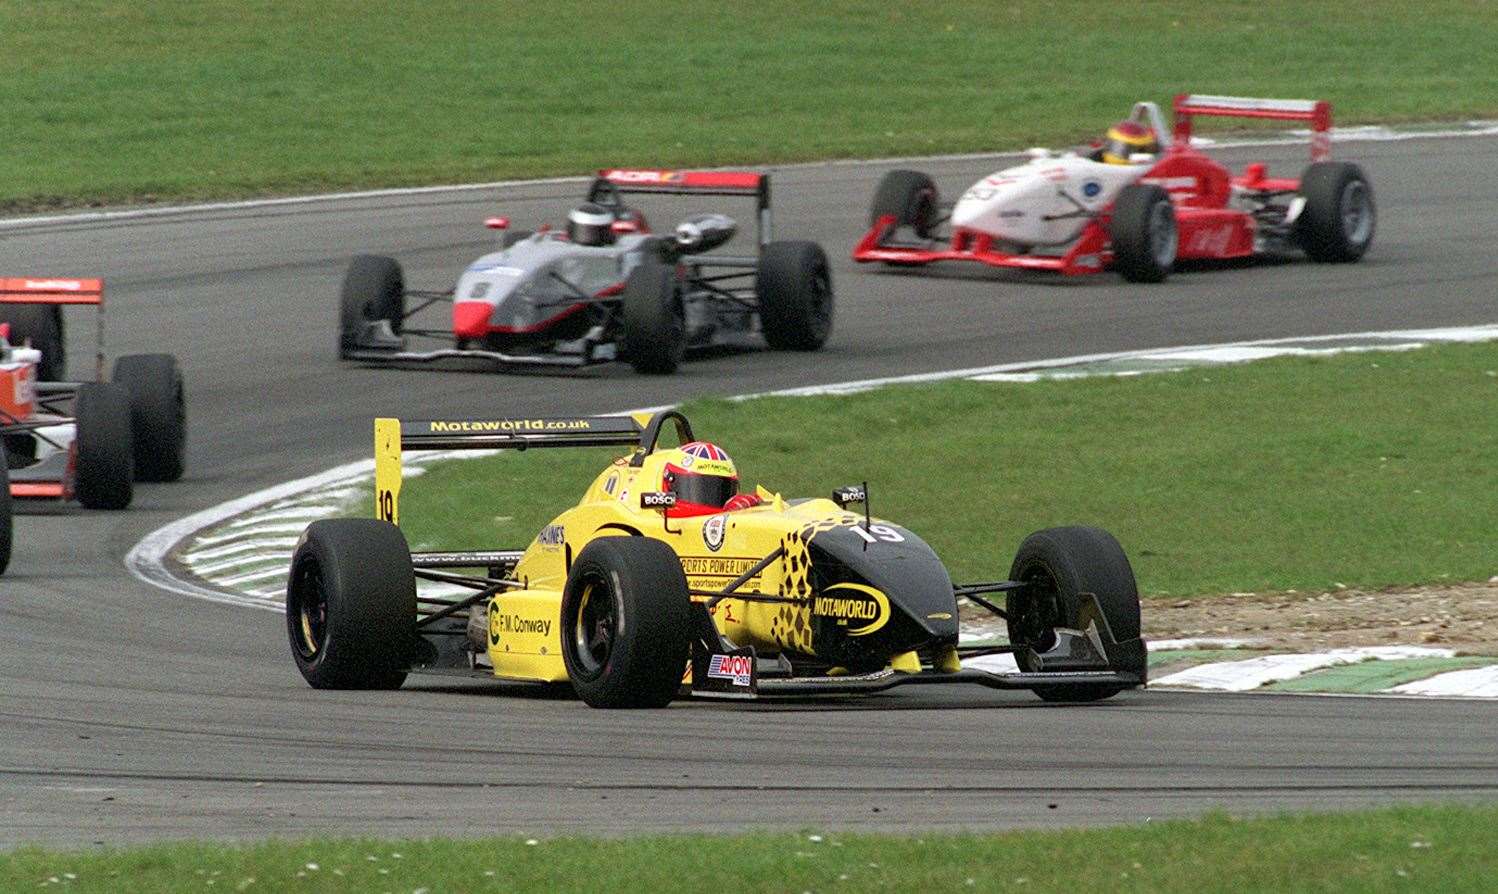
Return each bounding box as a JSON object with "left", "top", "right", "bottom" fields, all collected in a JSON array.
[{"left": 0, "top": 138, "right": 1498, "bottom": 845}]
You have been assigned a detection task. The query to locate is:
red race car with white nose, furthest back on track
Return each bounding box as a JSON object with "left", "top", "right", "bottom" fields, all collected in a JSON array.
[{"left": 852, "top": 94, "right": 1375, "bottom": 283}]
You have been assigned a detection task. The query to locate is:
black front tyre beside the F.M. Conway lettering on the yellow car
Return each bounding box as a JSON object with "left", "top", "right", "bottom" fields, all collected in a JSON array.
[{"left": 562, "top": 538, "right": 692, "bottom": 708}]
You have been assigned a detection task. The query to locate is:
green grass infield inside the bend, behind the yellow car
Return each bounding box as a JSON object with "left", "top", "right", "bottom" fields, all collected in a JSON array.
[{"left": 392, "top": 343, "right": 1498, "bottom": 595}]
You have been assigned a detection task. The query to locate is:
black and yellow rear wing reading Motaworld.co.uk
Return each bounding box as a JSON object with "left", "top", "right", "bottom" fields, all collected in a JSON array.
[{"left": 375, "top": 416, "right": 649, "bottom": 524}]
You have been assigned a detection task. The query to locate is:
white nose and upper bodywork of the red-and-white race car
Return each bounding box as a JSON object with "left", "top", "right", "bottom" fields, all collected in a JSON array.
[{"left": 951, "top": 102, "right": 1168, "bottom": 249}]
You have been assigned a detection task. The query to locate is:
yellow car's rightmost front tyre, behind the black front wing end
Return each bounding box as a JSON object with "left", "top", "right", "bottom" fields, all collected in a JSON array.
[{"left": 1004, "top": 527, "right": 1140, "bottom": 702}]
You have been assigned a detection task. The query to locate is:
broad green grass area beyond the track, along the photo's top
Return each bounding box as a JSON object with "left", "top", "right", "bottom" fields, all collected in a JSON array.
[{"left": 0, "top": 0, "right": 1498, "bottom": 210}]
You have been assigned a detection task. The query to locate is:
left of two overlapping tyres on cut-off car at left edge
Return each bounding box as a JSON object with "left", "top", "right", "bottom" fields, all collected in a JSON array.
[{"left": 73, "top": 382, "right": 135, "bottom": 509}]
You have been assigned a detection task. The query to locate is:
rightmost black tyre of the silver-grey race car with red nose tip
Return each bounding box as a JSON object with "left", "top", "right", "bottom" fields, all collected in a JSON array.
[{"left": 755, "top": 241, "right": 833, "bottom": 350}]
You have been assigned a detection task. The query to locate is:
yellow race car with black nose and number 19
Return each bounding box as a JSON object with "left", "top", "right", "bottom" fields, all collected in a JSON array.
[{"left": 286, "top": 410, "right": 1146, "bottom": 708}]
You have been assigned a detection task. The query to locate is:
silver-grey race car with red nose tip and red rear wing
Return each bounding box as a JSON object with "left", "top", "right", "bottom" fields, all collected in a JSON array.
[{"left": 339, "top": 169, "right": 833, "bottom": 373}]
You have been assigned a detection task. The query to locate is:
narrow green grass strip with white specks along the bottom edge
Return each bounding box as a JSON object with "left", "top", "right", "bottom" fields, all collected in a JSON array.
[{"left": 0, "top": 807, "right": 1498, "bottom": 894}]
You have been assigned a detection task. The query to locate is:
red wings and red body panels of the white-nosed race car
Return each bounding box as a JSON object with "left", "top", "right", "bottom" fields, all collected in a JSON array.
[{"left": 852, "top": 93, "right": 1332, "bottom": 276}]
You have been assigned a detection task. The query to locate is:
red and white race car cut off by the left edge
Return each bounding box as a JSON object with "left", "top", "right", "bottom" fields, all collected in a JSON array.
[{"left": 0, "top": 277, "right": 187, "bottom": 515}]
